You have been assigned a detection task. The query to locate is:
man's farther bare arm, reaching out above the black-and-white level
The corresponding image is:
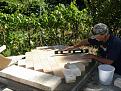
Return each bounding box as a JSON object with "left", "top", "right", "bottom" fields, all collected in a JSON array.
[{"left": 63, "top": 39, "right": 90, "bottom": 50}]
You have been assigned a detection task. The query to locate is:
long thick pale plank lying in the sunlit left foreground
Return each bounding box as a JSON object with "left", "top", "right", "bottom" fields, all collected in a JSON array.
[{"left": 0, "top": 66, "right": 61, "bottom": 91}]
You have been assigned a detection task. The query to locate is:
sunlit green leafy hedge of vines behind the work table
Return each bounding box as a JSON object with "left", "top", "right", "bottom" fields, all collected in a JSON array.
[{"left": 0, "top": 0, "right": 92, "bottom": 56}]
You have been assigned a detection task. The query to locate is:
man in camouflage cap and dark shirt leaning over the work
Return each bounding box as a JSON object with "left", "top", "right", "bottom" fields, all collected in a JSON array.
[{"left": 64, "top": 23, "right": 121, "bottom": 75}]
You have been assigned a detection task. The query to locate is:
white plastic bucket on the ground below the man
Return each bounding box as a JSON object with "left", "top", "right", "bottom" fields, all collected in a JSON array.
[{"left": 98, "top": 64, "right": 115, "bottom": 85}]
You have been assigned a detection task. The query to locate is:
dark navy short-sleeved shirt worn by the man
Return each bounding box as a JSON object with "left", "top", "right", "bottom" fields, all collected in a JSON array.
[{"left": 88, "top": 35, "right": 121, "bottom": 75}]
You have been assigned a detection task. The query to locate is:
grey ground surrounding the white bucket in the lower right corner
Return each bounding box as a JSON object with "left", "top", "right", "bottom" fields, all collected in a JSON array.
[{"left": 80, "top": 69, "right": 121, "bottom": 91}]
